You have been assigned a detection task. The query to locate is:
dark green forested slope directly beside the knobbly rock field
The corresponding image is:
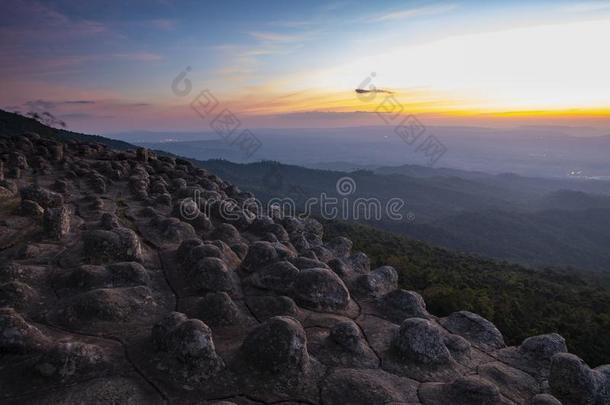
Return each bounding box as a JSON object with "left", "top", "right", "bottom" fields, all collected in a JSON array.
[{"left": 324, "top": 221, "right": 610, "bottom": 365}]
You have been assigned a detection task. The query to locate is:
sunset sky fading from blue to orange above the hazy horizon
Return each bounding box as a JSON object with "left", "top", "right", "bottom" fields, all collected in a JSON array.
[{"left": 0, "top": 0, "right": 610, "bottom": 133}]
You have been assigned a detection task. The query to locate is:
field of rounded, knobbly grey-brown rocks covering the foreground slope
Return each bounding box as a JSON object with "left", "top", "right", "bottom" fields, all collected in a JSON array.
[{"left": 0, "top": 134, "right": 610, "bottom": 405}]
